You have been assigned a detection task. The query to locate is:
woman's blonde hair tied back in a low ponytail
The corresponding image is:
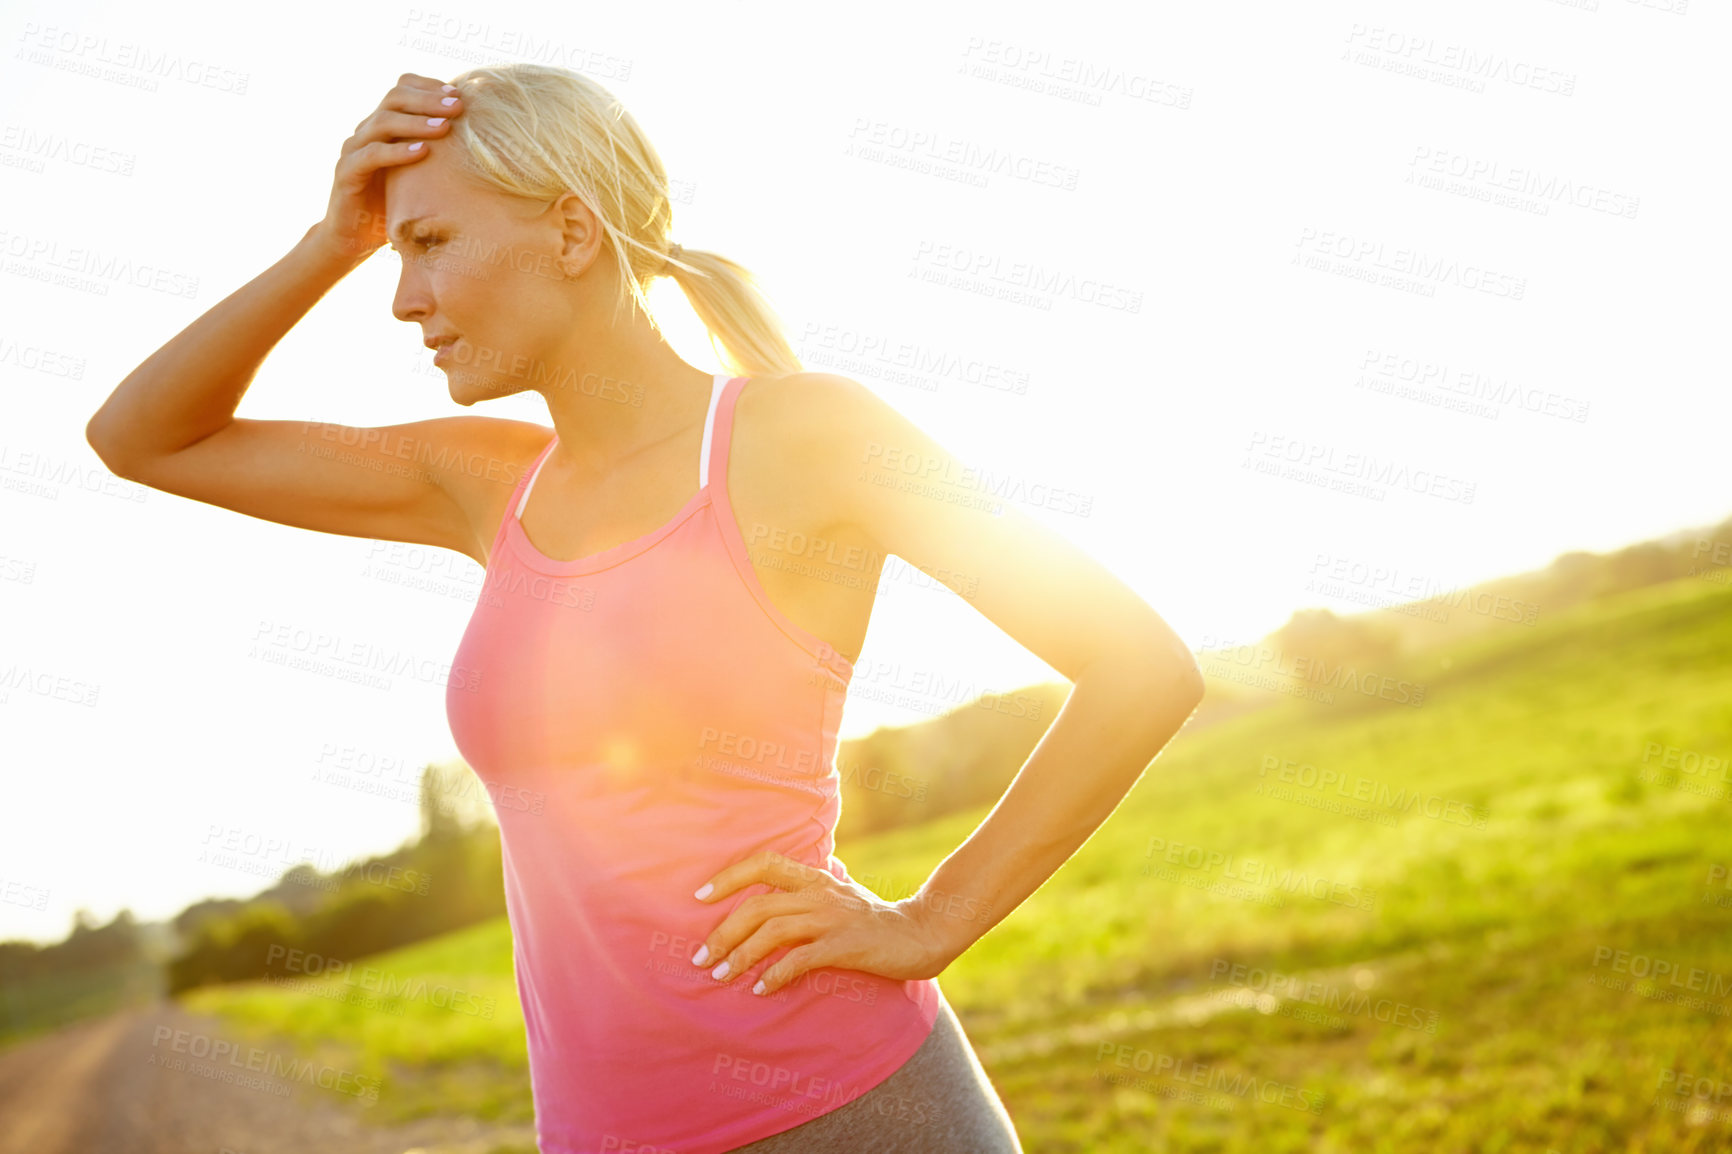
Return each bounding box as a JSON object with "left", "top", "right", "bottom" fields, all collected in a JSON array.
[{"left": 450, "top": 62, "right": 804, "bottom": 376}]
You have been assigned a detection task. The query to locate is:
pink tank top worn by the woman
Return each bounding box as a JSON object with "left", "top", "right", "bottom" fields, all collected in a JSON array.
[{"left": 445, "top": 374, "right": 942, "bottom": 1154}]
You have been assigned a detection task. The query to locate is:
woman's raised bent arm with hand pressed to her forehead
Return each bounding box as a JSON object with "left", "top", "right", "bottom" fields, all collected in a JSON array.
[{"left": 85, "top": 73, "right": 547, "bottom": 565}]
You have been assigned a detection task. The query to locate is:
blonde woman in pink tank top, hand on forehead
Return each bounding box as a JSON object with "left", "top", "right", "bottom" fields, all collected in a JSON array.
[{"left": 87, "top": 64, "right": 1202, "bottom": 1154}]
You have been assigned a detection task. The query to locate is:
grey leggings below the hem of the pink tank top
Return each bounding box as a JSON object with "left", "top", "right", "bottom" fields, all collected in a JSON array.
[{"left": 734, "top": 998, "right": 1022, "bottom": 1154}]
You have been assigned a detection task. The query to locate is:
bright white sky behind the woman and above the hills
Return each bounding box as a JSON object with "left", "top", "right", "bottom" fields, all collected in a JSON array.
[{"left": 0, "top": 0, "right": 1732, "bottom": 939}]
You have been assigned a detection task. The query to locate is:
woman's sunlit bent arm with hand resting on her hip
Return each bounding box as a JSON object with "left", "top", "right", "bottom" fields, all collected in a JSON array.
[{"left": 693, "top": 373, "right": 1204, "bottom": 993}]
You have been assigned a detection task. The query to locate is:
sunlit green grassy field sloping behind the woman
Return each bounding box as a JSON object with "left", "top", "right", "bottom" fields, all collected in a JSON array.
[{"left": 175, "top": 579, "right": 1732, "bottom": 1154}]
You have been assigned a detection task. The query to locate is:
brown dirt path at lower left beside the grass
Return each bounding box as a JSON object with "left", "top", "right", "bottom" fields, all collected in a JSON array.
[{"left": 0, "top": 1002, "right": 535, "bottom": 1154}]
